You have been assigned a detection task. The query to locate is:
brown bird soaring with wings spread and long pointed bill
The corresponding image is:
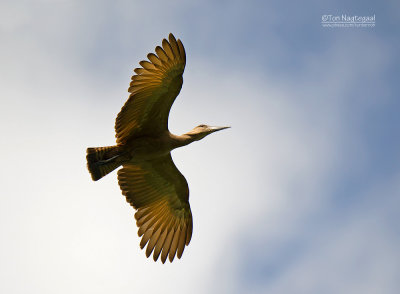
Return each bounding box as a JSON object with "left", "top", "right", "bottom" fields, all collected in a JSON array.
[{"left": 86, "top": 33, "right": 230, "bottom": 263}]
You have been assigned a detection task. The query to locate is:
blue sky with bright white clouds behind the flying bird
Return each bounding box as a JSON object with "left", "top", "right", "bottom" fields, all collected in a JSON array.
[{"left": 0, "top": 0, "right": 400, "bottom": 294}]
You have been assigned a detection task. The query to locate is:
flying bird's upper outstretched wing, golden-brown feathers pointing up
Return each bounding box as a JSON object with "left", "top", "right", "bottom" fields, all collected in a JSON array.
[{"left": 115, "top": 34, "right": 186, "bottom": 144}]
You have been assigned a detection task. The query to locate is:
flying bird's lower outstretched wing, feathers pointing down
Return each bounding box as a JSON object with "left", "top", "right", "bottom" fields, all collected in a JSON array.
[{"left": 118, "top": 153, "right": 193, "bottom": 263}]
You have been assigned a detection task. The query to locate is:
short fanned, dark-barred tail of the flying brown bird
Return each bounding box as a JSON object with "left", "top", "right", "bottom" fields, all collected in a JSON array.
[{"left": 86, "top": 146, "right": 121, "bottom": 181}]
